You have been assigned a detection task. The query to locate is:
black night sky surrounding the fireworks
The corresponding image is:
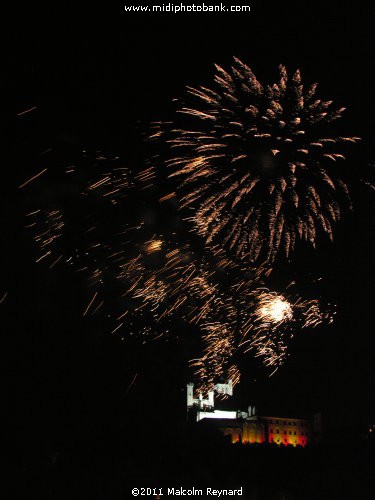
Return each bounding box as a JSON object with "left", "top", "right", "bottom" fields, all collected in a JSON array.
[{"left": 0, "top": 1, "right": 375, "bottom": 496}]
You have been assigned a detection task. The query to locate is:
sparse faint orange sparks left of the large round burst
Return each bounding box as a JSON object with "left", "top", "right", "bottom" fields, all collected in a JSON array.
[{"left": 25, "top": 150, "right": 152, "bottom": 272}]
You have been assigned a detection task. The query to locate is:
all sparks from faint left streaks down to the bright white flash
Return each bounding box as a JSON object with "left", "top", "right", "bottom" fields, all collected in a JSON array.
[{"left": 26, "top": 134, "right": 338, "bottom": 393}]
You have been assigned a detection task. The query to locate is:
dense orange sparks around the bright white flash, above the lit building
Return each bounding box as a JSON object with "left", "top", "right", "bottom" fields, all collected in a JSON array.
[{"left": 118, "top": 235, "right": 333, "bottom": 394}]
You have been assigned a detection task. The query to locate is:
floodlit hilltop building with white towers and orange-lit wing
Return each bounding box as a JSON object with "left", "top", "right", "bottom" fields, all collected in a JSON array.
[{"left": 187, "top": 384, "right": 321, "bottom": 447}]
